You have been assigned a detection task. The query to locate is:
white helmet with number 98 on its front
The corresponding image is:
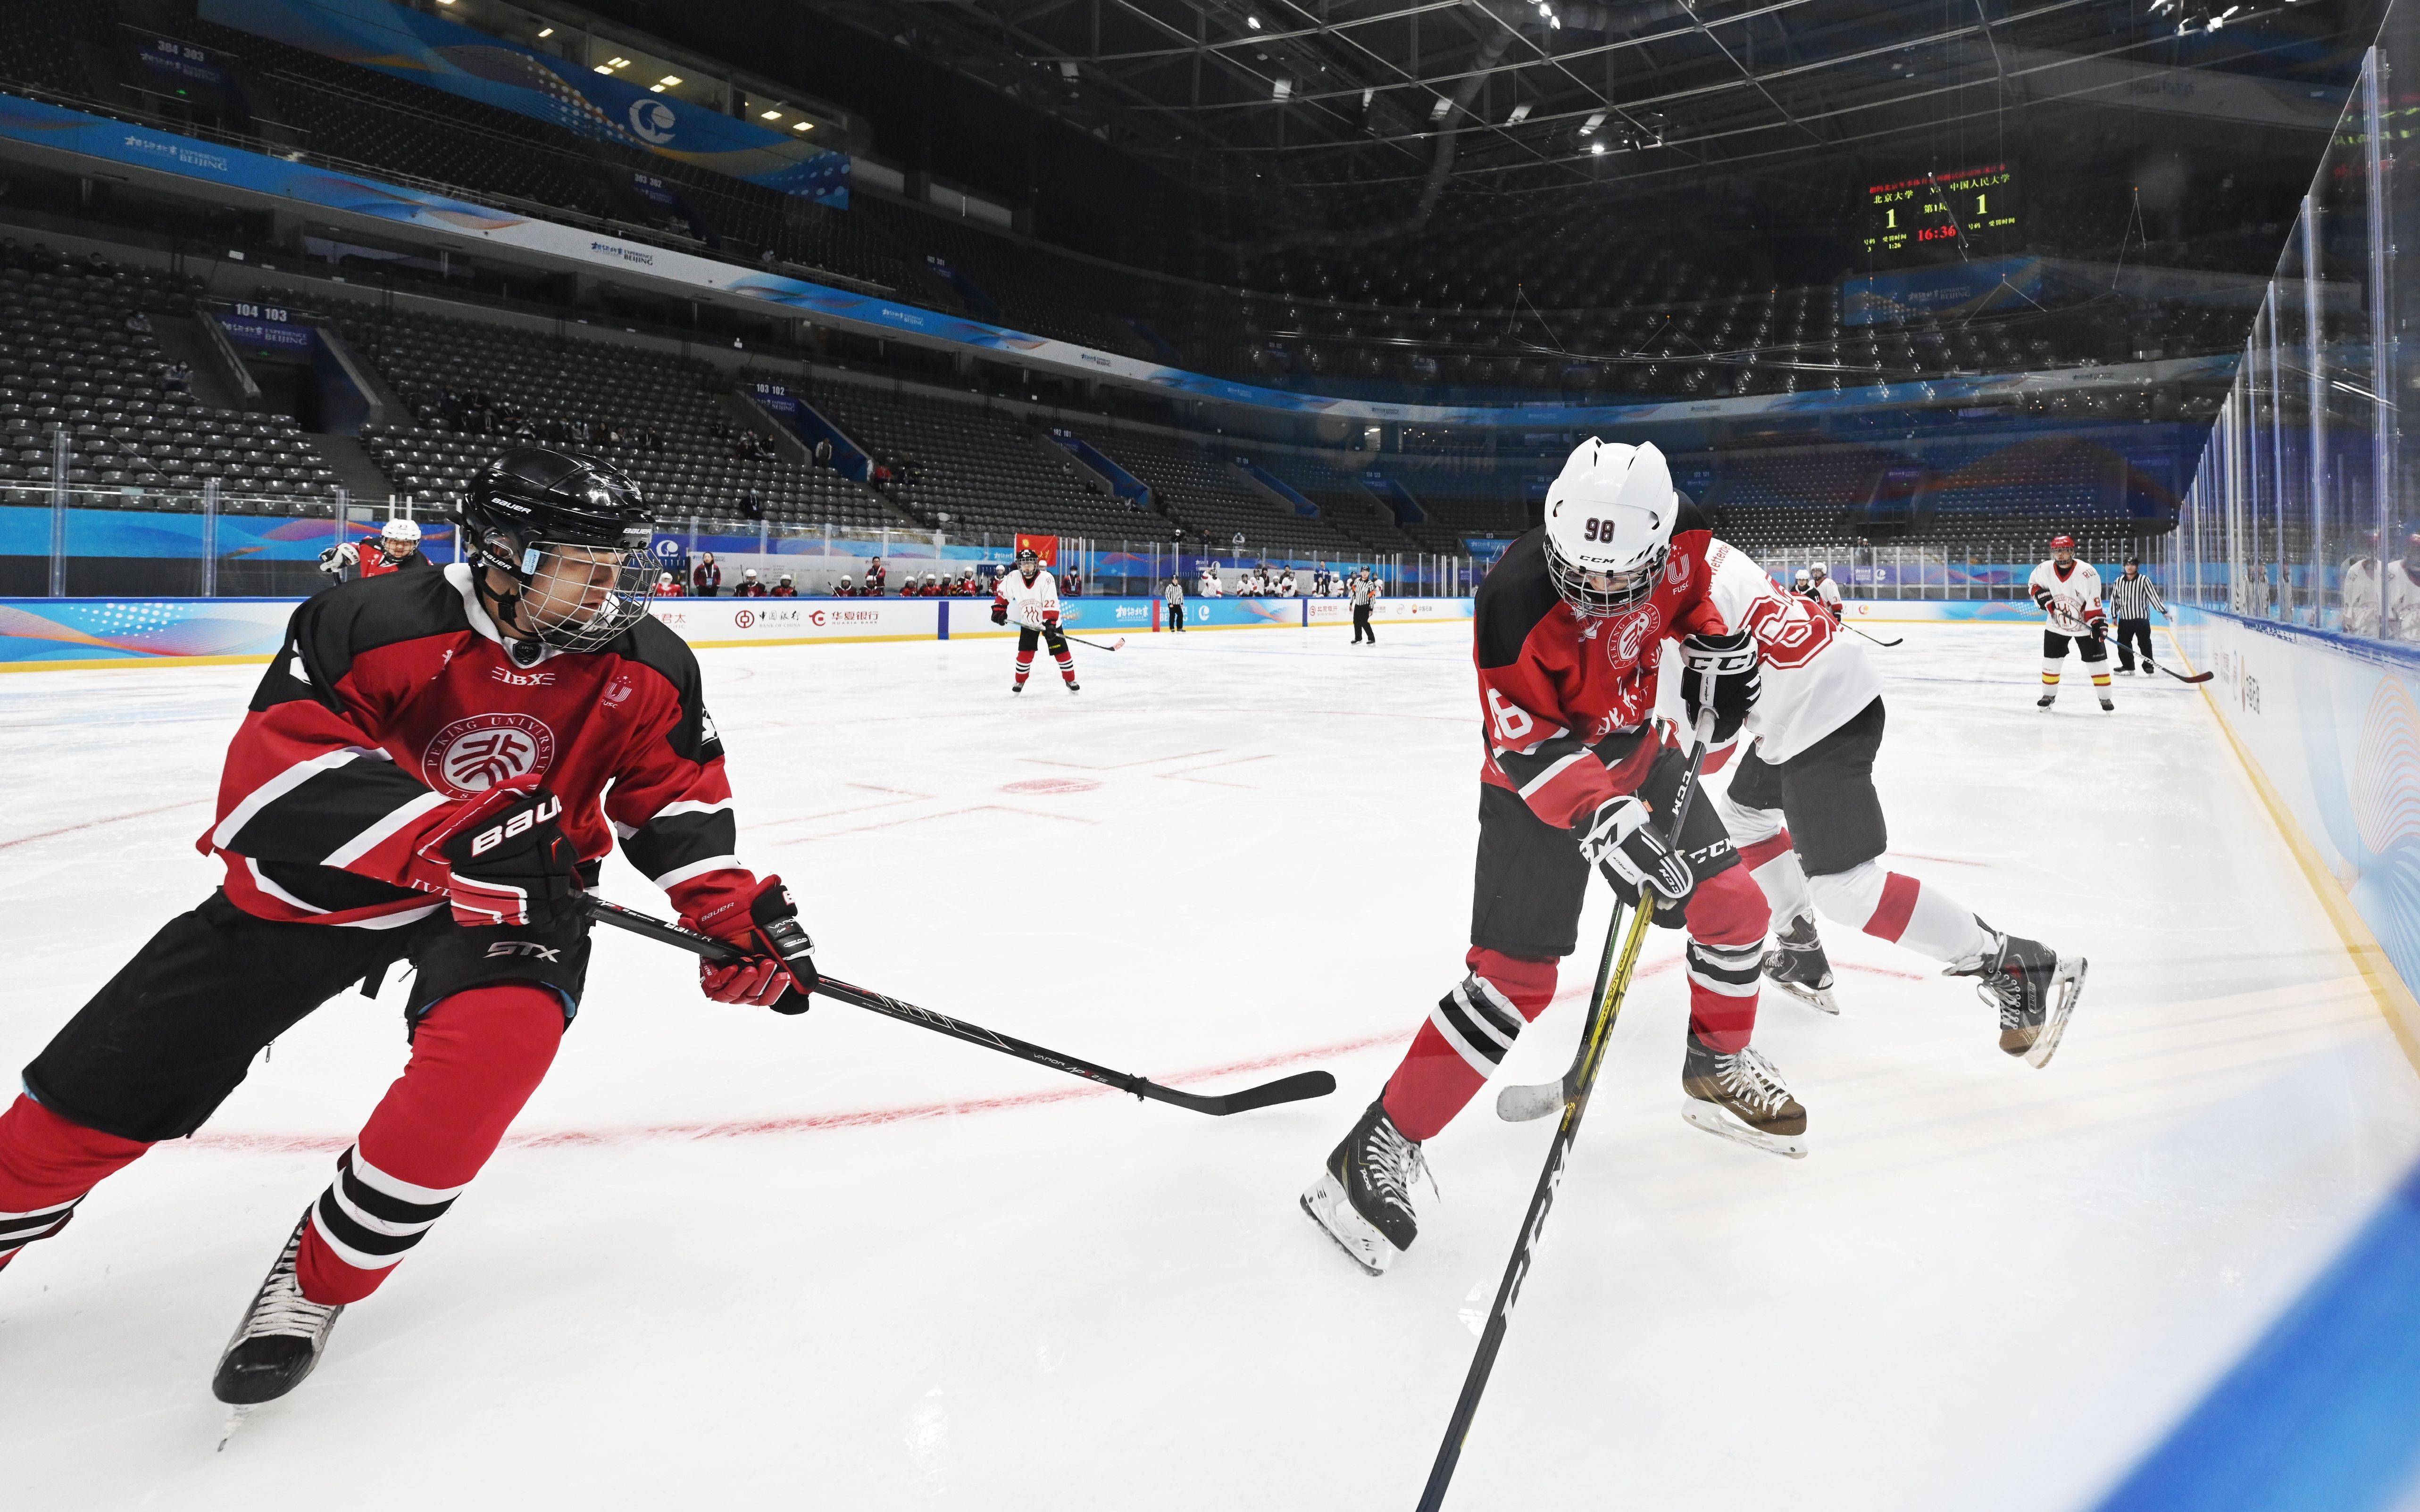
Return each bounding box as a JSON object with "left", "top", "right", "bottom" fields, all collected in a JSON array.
[{"left": 1546, "top": 435, "right": 1679, "bottom": 617}]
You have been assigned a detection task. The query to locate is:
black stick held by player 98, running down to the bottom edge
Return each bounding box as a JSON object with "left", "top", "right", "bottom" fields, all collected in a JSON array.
[{"left": 1420, "top": 697, "right": 1713, "bottom": 1512}]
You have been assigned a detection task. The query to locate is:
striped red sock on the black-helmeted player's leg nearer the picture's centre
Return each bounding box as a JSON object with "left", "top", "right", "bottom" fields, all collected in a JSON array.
[{"left": 295, "top": 982, "right": 564, "bottom": 1306}]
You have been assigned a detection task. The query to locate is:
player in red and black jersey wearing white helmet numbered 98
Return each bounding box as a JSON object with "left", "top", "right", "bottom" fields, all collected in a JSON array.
[{"left": 1302, "top": 438, "right": 1808, "bottom": 1275}]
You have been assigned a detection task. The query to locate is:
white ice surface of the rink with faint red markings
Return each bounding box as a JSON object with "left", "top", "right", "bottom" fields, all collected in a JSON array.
[{"left": 0, "top": 624, "right": 2420, "bottom": 1512}]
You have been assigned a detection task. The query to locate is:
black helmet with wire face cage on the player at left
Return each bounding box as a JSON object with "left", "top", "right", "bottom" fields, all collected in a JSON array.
[{"left": 462, "top": 448, "right": 663, "bottom": 651}]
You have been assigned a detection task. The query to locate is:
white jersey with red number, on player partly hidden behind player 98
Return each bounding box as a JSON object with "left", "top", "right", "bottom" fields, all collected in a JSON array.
[{"left": 1706, "top": 540, "right": 1883, "bottom": 764}]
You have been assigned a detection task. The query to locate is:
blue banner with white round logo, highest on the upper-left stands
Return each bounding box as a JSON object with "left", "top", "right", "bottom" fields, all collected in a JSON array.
[{"left": 201, "top": 0, "right": 850, "bottom": 206}]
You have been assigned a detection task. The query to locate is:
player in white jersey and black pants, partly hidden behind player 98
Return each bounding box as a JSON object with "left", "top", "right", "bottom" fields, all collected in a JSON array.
[{"left": 1684, "top": 542, "right": 2086, "bottom": 1050}]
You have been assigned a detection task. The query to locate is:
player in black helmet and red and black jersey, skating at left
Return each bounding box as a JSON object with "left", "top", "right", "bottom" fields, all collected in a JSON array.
[{"left": 0, "top": 448, "right": 818, "bottom": 1405}]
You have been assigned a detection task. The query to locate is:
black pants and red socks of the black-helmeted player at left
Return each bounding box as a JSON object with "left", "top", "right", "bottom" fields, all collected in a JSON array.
[{"left": 0, "top": 895, "right": 588, "bottom": 1304}]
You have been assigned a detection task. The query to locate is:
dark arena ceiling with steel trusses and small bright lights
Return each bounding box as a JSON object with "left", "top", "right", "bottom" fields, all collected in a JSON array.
[{"left": 816, "top": 0, "right": 2362, "bottom": 225}]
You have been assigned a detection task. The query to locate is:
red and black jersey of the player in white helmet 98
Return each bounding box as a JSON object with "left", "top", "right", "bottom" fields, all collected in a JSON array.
[{"left": 1471, "top": 513, "right": 1726, "bottom": 827}]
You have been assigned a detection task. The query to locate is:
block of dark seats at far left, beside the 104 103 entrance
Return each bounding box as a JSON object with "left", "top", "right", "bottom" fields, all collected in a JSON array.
[{"left": 0, "top": 242, "right": 336, "bottom": 515}]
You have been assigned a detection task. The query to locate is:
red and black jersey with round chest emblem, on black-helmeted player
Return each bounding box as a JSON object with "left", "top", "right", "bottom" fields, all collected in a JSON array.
[{"left": 196, "top": 564, "right": 755, "bottom": 929}]
